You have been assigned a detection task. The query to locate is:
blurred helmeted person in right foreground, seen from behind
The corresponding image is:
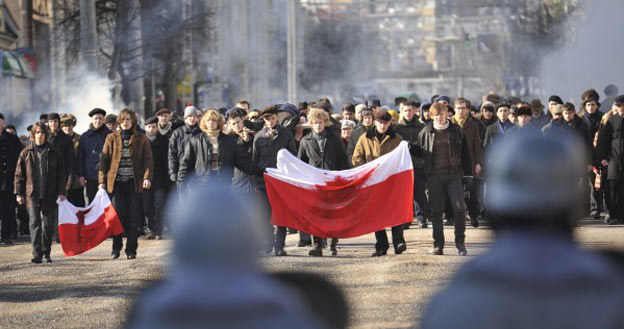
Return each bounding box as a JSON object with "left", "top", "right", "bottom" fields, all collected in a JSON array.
[{"left": 421, "top": 133, "right": 624, "bottom": 329}]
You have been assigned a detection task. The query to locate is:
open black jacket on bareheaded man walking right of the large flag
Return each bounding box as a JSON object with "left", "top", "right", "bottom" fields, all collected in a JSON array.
[{"left": 418, "top": 123, "right": 472, "bottom": 176}]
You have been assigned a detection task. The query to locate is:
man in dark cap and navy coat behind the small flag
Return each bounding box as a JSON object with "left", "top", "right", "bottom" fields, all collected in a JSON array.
[{"left": 76, "top": 108, "right": 112, "bottom": 203}]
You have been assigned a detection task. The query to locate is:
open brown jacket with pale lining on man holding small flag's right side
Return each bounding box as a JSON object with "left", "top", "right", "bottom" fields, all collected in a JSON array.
[{"left": 98, "top": 128, "right": 153, "bottom": 193}]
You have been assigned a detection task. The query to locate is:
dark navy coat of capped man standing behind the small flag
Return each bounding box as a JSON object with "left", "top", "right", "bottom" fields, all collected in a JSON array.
[{"left": 76, "top": 125, "right": 112, "bottom": 181}]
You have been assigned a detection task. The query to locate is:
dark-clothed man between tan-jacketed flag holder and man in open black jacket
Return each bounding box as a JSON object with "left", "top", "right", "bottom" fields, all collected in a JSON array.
[{"left": 394, "top": 101, "right": 429, "bottom": 228}]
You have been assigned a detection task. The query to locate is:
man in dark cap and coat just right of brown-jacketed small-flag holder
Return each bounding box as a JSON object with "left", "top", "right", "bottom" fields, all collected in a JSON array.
[{"left": 141, "top": 117, "right": 168, "bottom": 240}]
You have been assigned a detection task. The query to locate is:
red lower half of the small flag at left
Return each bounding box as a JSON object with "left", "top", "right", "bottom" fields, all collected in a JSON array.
[{"left": 58, "top": 205, "right": 123, "bottom": 256}]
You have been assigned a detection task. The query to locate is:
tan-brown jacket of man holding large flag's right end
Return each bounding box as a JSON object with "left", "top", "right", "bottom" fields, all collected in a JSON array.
[{"left": 352, "top": 127, "right": 403, "bottom": 167}]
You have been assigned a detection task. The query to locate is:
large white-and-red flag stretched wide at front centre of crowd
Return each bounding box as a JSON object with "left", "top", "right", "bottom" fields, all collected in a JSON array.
[{"left": 264, "top": 141, "right": 414, "bottom": 238}]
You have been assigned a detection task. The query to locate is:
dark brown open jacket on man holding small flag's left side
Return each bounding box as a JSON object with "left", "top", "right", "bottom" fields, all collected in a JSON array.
[{"left": 14, "top": 143, "right": 67, "bottom": 207}]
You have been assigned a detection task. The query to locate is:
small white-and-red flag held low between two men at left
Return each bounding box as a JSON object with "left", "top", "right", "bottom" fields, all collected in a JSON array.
[{"left": 57, "top": 189, "right": 123, "bottom": 256}]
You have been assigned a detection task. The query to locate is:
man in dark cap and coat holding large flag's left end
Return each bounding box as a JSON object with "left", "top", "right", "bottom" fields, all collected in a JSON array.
[{"left": 252, "top": 106, "right": 297, "bottom": 256}]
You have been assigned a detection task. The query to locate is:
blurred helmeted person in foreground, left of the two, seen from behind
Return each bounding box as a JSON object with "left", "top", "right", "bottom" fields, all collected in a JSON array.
[{"left": 127, "top": 184, "right": 344, "bottom": 329}]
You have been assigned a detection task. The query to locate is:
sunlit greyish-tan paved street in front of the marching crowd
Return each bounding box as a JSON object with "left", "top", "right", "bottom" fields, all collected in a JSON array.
[{"left": 0, "top": 223, "right": 624, "bottom": 329}]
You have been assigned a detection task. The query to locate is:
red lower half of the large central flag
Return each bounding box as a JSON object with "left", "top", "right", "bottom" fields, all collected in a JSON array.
[{"left": 264, "top": 170, "right": 414, "bottom": 238}]
